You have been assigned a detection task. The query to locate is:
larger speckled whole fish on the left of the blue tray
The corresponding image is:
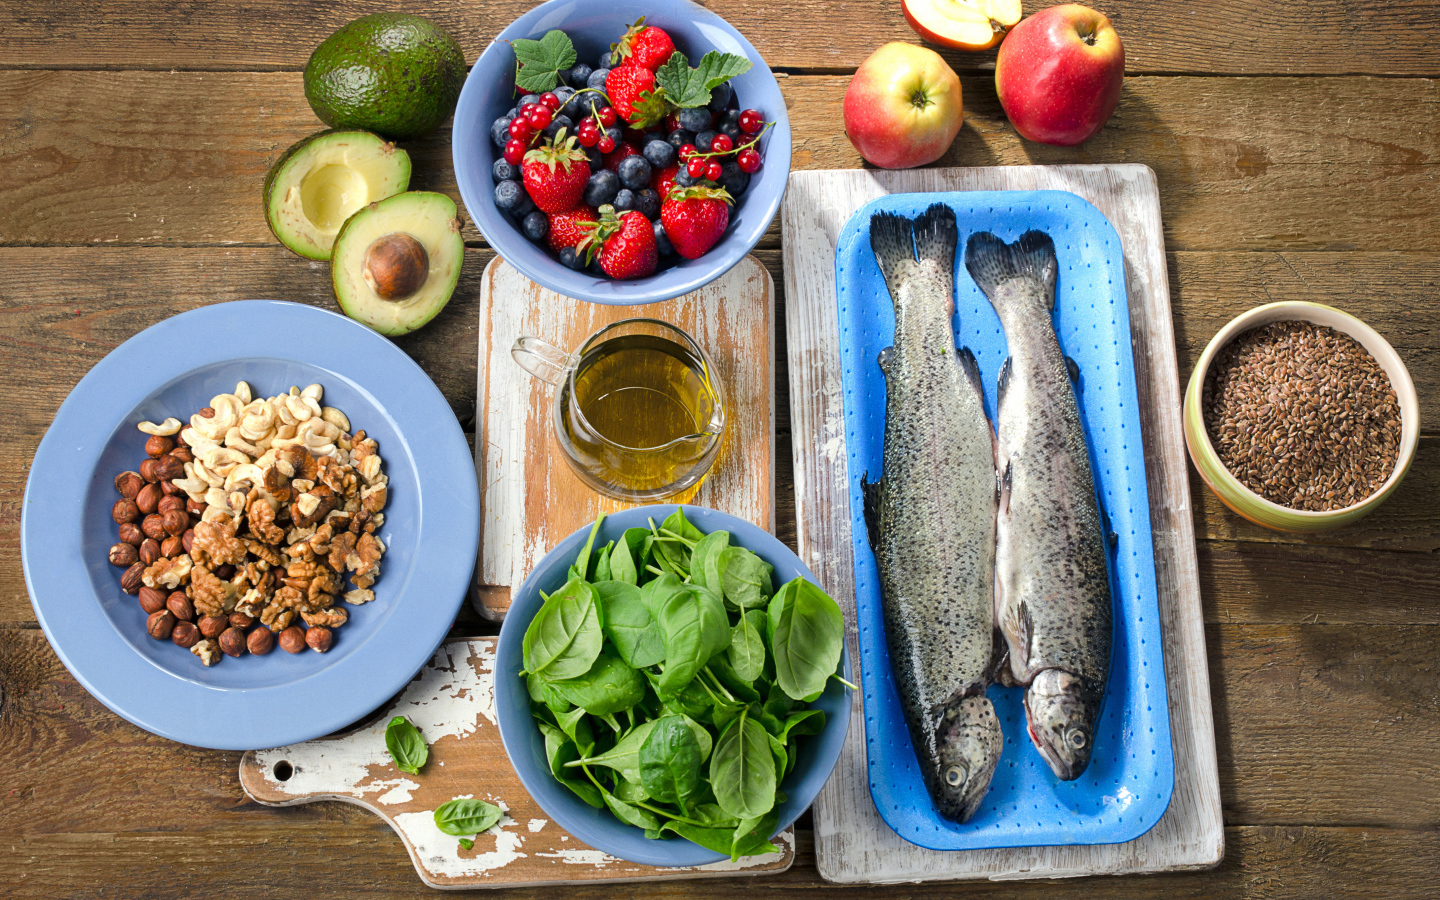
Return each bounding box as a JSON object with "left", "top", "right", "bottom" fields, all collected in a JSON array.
[{"left": 865, "top": 204, "right": 1004, "bottom": 822}]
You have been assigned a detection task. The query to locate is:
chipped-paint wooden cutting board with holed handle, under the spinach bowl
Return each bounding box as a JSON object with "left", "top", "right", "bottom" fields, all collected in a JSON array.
[{"left": 240, "top": 638, "right": 795, "bottom": 888}]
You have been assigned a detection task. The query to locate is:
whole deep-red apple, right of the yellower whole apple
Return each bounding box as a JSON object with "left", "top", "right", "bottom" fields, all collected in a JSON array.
[{"left": 995, "top": 3, "right": 1125, "bottom": 147}]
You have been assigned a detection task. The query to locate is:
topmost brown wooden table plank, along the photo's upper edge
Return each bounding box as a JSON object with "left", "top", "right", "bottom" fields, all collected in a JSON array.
[{"left": 0, "top": 0, "right": 1440, "bottom": 75}]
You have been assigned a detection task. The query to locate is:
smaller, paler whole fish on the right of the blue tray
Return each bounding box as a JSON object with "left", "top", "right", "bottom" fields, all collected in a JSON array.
[{"left": 965, "top": 230, "right": 1113, "bottom": 780}]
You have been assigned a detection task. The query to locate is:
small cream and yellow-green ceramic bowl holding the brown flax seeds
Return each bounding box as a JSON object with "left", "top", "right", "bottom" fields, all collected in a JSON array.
[{"left": 1185, "top": 301, "right": 1420, "bottom": 531}]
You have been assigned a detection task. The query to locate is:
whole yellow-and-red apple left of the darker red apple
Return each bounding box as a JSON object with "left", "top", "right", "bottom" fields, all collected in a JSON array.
[{"left": 844, "top": 43, "right": 962, "bottom": 168}]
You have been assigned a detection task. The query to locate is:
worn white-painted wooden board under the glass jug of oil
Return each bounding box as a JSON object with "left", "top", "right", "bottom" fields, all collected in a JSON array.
[{"left": 475, "top": 256, "right": 775, "bottom": 621}]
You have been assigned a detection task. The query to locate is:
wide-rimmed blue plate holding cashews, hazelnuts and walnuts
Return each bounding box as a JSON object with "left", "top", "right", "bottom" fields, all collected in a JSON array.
[{"left": 20, "top": 300, "right": 480, "bottom": 750}]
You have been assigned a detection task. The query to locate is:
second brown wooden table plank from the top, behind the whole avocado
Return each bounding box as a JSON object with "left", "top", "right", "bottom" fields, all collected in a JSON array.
[{"left": 0, "top": 71, "right": 1440, "bottom": 252}]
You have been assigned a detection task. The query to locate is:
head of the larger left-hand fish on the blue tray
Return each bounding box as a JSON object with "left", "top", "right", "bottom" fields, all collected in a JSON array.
[{"left": 932, "top": 694, "right": 1004, "bottom": 822}]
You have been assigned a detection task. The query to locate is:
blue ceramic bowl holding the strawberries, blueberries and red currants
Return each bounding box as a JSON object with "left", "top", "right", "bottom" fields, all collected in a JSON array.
[{"left": 451, "top": 0, "right": 791, "bottom": 305}]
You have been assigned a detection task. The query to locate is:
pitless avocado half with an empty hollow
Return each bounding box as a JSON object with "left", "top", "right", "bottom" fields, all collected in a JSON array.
[{"left": 265, "top": 131, "right": 410, "bottom": 259}]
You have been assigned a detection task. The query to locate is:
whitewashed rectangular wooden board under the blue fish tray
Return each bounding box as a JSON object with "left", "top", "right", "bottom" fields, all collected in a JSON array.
[{"left": 780, "top": 166, "right": 1224, "bottom": 884}]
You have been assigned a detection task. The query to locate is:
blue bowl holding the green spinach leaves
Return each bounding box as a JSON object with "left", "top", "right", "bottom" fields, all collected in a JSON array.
[{"left": 495, "top": 504, "right": 852, "bottom": 865}]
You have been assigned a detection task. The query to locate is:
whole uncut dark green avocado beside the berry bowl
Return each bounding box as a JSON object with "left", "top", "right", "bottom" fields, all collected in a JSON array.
[{"left": 305, "top": 13, "right": 465, "bottom": 138}]
